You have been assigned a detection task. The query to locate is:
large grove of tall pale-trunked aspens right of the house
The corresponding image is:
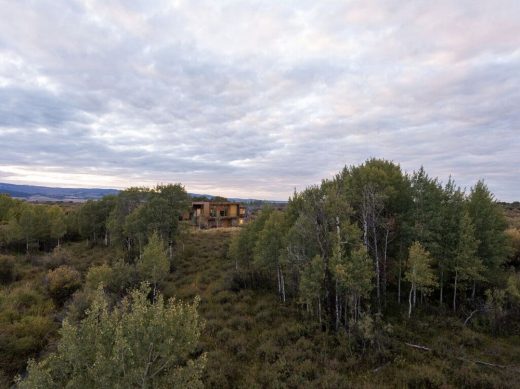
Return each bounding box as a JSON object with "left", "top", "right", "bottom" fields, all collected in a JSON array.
[{"left": 230, "top": 159, "right": 520, "bottom": 330}]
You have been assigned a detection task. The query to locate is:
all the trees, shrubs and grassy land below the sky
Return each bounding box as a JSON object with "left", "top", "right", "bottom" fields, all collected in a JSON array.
[{"left": 0, "top": 159, "right": 520, "bottom": 388}]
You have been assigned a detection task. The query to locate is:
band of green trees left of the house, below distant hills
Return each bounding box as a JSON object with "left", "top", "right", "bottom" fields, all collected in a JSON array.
[{"left": 0, "top": 184, "right": 190, "bottom": 257}]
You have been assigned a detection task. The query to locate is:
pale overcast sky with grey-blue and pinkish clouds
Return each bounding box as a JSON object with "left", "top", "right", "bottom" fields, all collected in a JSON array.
[{"left": 0, "top": 0, "right": 520, "bottom": 201}]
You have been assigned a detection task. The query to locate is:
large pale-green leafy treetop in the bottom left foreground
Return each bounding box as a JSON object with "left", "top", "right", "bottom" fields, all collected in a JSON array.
[{"left": 18, "top": 284, "right": 206, "bottom": 389}]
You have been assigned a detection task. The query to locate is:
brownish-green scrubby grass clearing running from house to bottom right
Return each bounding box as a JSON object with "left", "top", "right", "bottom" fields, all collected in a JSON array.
[{"left": 163, "top": 229, "right": 520, "bottom": 388}]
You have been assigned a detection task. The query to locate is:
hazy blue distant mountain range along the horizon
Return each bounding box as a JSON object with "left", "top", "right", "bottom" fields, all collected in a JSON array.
[{"left": 0, "top": 183, "right": 286, "bottom": 204}]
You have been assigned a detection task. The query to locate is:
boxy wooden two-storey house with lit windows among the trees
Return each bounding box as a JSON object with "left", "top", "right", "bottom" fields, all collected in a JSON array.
[{"left": 189, "top": 201, "right": 246, "bottom": 228}]
